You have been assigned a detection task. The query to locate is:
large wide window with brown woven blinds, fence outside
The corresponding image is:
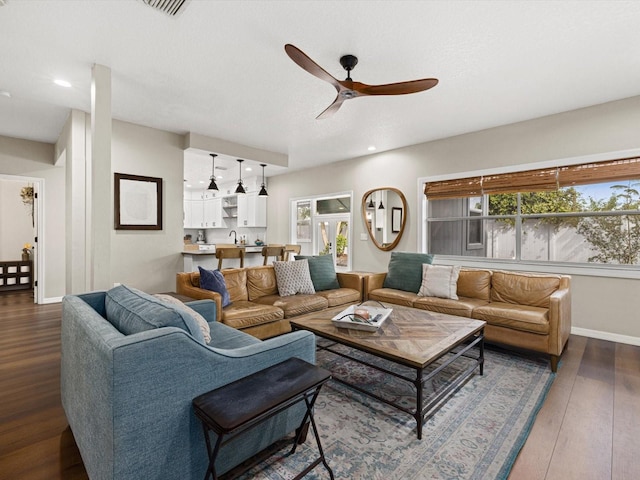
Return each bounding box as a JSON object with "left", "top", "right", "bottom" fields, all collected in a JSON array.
[{"left": 425, "top": 158, "right": 640, "bottom": 268}]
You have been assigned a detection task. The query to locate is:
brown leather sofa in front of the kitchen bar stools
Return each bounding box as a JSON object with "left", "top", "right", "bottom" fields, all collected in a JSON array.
[{"left": 176, "top": 265, "right": 363, "bottom": 339}]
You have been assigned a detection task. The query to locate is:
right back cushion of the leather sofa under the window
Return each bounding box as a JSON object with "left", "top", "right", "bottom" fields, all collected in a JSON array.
[{"left": 491, "top": 271, "right": 560, "bottom": 308}]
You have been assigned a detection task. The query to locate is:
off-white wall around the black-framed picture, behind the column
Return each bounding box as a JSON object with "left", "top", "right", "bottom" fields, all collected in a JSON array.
[{"left": 56, "top": 112, "right": 184, "bottom": 293}]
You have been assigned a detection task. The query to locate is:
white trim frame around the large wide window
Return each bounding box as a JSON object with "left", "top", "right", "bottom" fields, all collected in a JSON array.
[{"left": 416, "top": 148, "right": 640, "bottom": 279}]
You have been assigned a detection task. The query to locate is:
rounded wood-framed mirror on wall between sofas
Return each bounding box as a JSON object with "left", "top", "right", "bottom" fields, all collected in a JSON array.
[{"left": 362, "top": 187, "right": 407, "bottom": 252}]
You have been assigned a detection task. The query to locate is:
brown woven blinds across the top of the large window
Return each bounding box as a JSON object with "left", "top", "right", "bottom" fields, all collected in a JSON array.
[{"left": 424, "top": 158, "right": 640, "bottom": 200}]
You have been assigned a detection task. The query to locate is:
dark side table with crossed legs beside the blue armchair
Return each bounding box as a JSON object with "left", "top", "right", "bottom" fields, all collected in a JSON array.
[{"left": 193, "top": 358, "right": 334, "bottom": 480}]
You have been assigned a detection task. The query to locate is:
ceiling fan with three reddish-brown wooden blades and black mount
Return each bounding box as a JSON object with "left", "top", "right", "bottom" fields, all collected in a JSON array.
[{"left": 284, "top": 43, "right": 438, "bottom": 119}]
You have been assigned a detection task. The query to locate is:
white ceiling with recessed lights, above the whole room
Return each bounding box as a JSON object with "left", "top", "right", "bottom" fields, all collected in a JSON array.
[{"left": 0, "top": 0, "right": 640, "bottom": 185}]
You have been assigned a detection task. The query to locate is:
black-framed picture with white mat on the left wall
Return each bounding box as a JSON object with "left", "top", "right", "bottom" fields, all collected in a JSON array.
[{"left": 114, "top": 173, "right": 162, "bottom": 230}]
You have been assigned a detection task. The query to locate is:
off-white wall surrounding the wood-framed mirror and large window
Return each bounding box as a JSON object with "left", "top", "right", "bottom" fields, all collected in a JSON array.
[{"left": 267, "top": 97, "right": 640, "bottom": 344}]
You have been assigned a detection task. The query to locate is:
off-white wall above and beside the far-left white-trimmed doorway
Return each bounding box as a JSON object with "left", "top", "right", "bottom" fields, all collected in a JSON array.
[{"left": 0, "top": 136, "right": 65, "bottom": 301}]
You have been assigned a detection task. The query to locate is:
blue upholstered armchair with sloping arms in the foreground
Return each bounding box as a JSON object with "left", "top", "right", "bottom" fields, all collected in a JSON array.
[{"left": 61, "top": 292, "right": 315, "bottom": 480}]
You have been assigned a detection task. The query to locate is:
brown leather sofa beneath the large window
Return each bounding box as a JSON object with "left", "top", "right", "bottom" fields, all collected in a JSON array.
[{"left": 364, "top": 268, "right": 571, "bottom": 372}]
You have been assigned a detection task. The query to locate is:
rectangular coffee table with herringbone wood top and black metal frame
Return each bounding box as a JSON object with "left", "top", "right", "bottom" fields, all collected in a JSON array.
[{"left": 290, "top": 302, "right": 485, "bottom": 439}]
